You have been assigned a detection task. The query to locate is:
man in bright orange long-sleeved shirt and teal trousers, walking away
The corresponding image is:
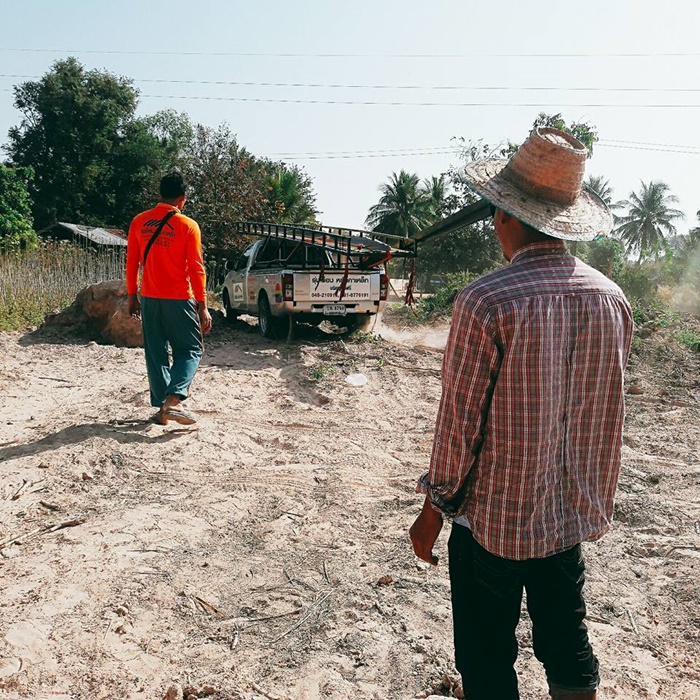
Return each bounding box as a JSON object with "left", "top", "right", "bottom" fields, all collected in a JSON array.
[{"left": 126, "top": 173, "right": 211, "bottom": 425}]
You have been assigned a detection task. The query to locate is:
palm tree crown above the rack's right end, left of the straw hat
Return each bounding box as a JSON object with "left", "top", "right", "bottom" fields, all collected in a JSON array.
[{"left": 365, "top": 170, "right": 432, "bottom": 238}]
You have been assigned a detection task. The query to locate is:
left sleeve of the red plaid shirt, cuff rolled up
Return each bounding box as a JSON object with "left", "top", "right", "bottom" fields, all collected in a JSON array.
[{"left": 418, "top": 287, "right": 501, "bottom": 516}]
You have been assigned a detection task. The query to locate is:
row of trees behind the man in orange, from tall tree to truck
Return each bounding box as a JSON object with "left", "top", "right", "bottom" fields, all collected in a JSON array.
[{"left": 7, "top": 58, "right": 316, "bottom": 243}]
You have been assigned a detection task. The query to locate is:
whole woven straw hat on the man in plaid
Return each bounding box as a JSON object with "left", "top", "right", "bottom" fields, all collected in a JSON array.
[{"left": 465, "top": 127, "right": 613, "bottom": 241}]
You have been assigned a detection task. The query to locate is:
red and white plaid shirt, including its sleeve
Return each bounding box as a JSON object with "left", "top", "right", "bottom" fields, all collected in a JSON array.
[{"left": 419, "top": 242, "right": 633, "bottom": 560}]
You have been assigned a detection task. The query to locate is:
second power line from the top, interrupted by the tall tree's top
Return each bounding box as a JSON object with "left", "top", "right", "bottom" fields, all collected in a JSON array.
[{"left": 0, "top": 73, "right": 700, "bottom": 93}]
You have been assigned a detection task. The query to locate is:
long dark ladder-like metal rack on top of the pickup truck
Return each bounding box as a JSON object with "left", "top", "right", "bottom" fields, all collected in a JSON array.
[{"left": 234, "top": 221, "right": 417, "bottom": 266}]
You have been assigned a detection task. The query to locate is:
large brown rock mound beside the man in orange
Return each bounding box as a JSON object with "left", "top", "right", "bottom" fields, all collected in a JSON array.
[{"left": 44, "top": 280, "right": 143, "bottom": 348}]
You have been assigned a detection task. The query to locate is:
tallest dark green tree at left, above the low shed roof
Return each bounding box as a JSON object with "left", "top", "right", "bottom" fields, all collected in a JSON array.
[{"left": 6, "top": 58, "right": 142, "bottom": 228}]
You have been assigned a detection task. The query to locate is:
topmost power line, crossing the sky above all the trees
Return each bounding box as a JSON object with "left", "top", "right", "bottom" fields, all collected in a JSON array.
[{"left": 0, "top": 47, "right": 700, "bottom": 59}]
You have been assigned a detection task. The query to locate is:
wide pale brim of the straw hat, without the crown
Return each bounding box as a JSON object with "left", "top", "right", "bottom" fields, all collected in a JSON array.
[{"left": 465, "top": 159, "right": 613, "bottom": 241}]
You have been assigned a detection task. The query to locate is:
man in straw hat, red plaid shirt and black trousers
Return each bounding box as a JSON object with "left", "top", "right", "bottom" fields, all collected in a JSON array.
[{"left": 410, "top": 128, "right": 633, "bottom": 700}]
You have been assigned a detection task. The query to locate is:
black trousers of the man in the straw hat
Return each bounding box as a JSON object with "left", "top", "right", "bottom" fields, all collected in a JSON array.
[{"left": 448, "top": 525, "right": 598, "bottom": 700}]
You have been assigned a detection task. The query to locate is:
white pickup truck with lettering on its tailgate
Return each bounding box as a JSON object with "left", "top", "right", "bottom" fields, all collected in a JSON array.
[{"left": 222, "top": 234, "right": 389, "bottom": 338}]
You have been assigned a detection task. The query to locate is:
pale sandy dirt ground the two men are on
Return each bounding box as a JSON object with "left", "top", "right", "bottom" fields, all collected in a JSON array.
[{"left": 0, "top": 314, "right": 700, "bottom": 700}]
